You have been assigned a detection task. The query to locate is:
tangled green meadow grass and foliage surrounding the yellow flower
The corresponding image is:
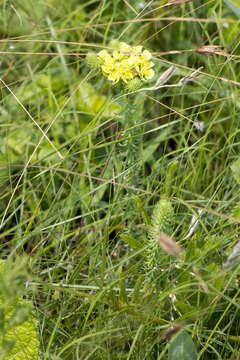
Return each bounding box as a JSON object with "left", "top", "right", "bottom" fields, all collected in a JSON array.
[{"left": 0, "top": 0, "right": 240, "bottom": 360}]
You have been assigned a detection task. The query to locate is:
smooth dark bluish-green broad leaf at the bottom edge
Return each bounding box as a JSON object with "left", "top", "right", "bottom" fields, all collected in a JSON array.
[{"left": 168, "top": 331, "right": 198, "bottom": 360}]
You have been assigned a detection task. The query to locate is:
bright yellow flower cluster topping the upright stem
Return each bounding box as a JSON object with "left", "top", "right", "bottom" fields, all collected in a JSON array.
[{"left": 98, "top": 42, "right": 154, "bottom": 83}]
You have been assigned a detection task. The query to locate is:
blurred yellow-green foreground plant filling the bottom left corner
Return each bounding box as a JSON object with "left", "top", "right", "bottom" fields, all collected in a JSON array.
[{"left": 0, "top": 258, "right": 39, "bottom": 360}]
